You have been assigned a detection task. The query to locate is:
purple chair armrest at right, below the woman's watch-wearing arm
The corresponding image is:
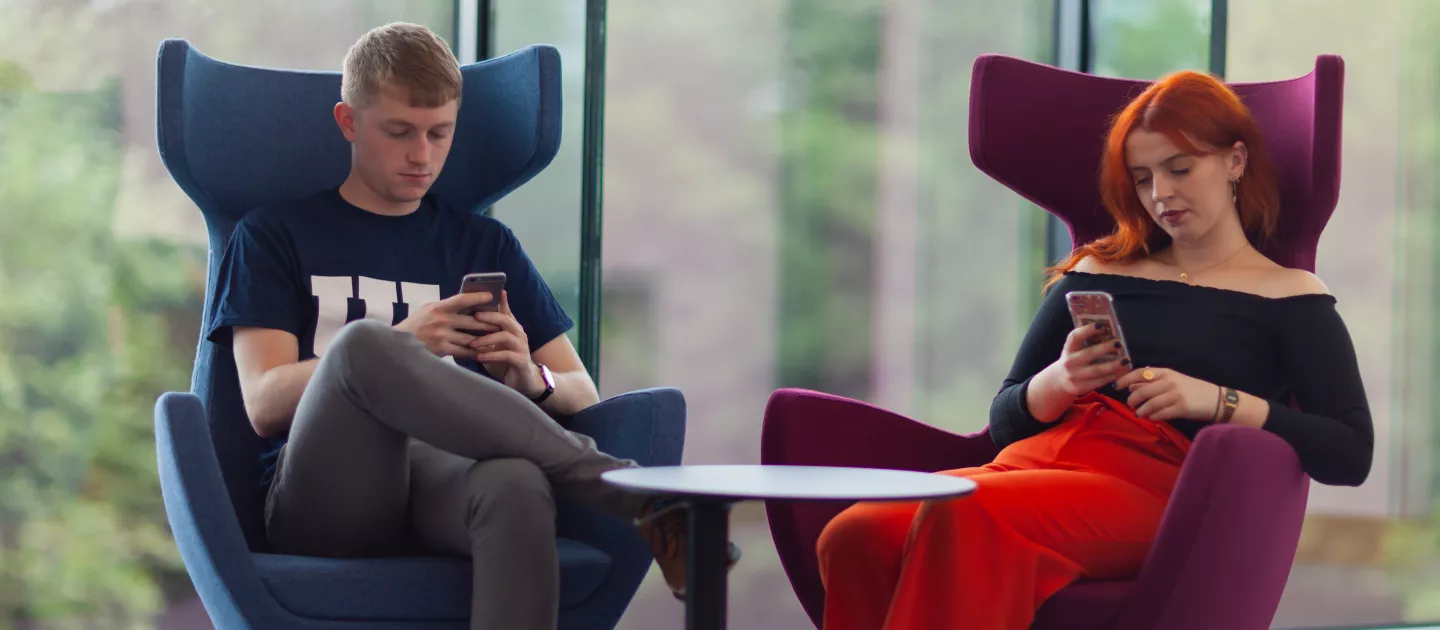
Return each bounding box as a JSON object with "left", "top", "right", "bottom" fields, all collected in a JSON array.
[{"left": 1116, "top": 424, "right": 1309, "bottom": 630}]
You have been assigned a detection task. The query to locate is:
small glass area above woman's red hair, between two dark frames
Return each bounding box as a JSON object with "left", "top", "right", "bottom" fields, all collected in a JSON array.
[{"left": 1090, "top": 0, "right": 1211, "bottom": 79}]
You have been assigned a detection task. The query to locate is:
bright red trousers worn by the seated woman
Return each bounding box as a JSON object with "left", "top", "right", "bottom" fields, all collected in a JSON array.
[{"left": 818, "top": 394, "right": 1189, "bottom": 630}]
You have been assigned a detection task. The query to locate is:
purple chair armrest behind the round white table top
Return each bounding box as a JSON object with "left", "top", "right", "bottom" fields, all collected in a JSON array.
[{"left": 760, "top": 390, "right": 996, "bottom": 627}]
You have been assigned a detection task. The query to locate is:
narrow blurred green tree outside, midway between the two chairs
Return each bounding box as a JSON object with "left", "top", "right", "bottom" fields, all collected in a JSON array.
[{"left": 779, "top": 0, "right": 883, "bottom": 398}]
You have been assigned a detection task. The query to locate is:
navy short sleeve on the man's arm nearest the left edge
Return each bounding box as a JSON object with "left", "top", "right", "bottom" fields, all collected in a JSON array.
[{"left": 206, "top": 214, "right": 308, "bottom": 345}]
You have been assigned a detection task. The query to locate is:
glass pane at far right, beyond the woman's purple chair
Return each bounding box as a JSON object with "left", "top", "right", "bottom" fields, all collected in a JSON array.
[{"left": 1227, "top": 0, "right": 1440, "bottom": 626}]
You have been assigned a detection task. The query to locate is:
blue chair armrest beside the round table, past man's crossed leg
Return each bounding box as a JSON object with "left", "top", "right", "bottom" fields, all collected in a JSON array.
[{"left": 556, "top": 388, "right": 685, "bottom": 627}]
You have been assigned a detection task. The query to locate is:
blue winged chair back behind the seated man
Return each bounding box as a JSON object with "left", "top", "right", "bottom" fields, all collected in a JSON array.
[{"left": 157, "top": 39, "right": 562, "bottom": 551}]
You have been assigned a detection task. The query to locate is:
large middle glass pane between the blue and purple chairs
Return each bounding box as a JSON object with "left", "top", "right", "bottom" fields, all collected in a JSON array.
[{"left": 600, "top": 0, "right": 1054, "bottom": 629}]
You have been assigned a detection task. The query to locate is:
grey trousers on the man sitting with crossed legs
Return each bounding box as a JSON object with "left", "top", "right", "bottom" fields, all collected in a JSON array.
[{"left": 265, "top": 321, "right": 644, "bottom": 629}]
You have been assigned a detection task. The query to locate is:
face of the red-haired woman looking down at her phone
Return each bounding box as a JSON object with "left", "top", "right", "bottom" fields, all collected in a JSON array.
[{"left": 1125, "top": 129, "right": 1246, "bottom": 240}]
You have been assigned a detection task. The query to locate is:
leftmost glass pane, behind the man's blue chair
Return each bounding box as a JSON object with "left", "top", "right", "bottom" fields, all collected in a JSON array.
[{"left": 0, "top": 0, "right": 454, "bottom": 629}]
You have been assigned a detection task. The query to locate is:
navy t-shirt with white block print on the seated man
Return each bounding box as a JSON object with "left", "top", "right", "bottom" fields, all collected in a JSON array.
[{"left": 206, "top": 190, "right": 573, "bottom": 485}]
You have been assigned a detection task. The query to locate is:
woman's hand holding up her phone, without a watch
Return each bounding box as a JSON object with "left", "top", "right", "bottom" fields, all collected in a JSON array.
[{"left": 1025, "top": 324, "right": 1130, "bottom": 423}]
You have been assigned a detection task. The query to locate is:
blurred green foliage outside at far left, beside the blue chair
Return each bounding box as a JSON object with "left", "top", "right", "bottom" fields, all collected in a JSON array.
[{"left": 0, "top": 73, "right": 199, "bottom": 627}]
